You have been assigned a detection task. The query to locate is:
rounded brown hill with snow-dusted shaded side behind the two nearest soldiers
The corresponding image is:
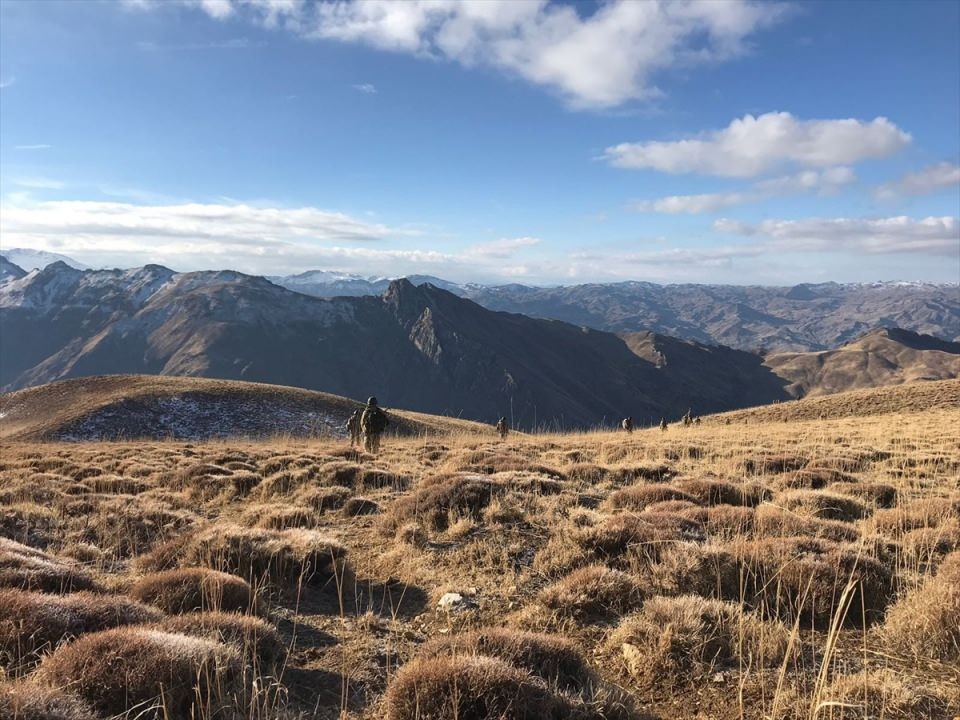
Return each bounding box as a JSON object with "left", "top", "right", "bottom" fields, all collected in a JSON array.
[{"left": 0, "top": 375, "right": 484, "bottom": 440}]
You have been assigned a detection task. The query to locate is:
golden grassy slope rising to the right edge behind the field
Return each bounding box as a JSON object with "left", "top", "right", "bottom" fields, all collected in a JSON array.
[{"left": 703, "top": 379, "right": 960, "bottom": 424}]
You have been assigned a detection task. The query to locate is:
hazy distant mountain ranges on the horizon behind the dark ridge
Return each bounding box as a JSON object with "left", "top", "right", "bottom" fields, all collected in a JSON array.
[{"left": 271, "top": 271, "right": 960, "bottom": 351}]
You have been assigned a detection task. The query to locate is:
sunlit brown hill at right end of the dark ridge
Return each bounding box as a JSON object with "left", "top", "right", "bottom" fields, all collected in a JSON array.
[{"left": 764, "top": 329, "right": 960, "bottom": 397}]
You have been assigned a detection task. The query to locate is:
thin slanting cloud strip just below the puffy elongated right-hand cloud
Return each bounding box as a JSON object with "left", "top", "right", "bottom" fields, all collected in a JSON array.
[{"left": 629, "top": 167, "right": 856, "bottom": 215}]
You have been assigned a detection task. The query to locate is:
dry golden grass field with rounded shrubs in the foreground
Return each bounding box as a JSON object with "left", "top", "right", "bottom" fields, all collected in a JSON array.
[{"left": 0, "top": 384, "right": 960, "bottom": 720}]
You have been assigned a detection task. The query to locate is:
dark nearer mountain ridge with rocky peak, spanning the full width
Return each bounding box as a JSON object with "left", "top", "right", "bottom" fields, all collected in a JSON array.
[{"left": 0, "top": 262, "right": 960, "bottom": 428}]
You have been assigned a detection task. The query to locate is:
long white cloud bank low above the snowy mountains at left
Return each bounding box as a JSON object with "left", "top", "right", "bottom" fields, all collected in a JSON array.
[{"left": 0, "top": 201, "right": 540, "bottom": 280}]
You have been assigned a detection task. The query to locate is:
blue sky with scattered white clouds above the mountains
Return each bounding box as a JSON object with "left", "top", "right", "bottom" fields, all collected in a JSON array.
[{"left": 0, "top": 0, "right": 960, "bottom": 284}]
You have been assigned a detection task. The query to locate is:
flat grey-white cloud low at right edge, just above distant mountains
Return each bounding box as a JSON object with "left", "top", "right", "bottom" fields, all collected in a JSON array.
[{"left": 713, "top": 216, "right": 960, "bottom": 256}]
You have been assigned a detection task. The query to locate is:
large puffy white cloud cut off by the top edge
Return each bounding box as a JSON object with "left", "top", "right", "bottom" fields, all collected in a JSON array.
[{"left": 125, "top": 0, "right": 788, "bottom": 108}]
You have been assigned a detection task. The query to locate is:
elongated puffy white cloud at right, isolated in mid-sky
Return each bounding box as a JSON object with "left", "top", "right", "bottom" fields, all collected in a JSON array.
[{"left": 604, "top": 112, "right": 911, "bottom": 177}]
